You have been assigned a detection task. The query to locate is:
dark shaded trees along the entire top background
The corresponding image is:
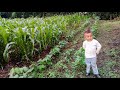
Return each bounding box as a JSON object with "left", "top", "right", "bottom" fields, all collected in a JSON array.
[{"left": 0, "top": 12, "right": 120, "bottom": 20}]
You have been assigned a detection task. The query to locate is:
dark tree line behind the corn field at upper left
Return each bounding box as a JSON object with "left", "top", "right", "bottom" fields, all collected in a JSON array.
[{"left": 0, "top": 12, "right": 75, "bottom": 18}]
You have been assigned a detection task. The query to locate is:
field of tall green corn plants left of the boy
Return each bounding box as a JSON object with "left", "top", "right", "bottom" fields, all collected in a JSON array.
[{"left": 0, "top": 13, "right": 89, "bottom": 63}]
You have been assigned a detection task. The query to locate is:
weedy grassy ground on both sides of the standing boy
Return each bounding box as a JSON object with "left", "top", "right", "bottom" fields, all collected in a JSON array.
[{"left": 41, "top": 21, "right": 120, "bottom": 78}]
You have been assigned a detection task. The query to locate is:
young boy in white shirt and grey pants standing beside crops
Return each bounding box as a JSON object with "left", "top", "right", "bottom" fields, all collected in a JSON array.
[{"left": 83, "top": 28, "right": 102, "bottom": 78}]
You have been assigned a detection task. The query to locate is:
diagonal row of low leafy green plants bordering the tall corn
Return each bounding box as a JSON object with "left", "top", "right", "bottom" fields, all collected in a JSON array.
[{"left": 9, "top": 41, "right": 66, "bottom": 78}]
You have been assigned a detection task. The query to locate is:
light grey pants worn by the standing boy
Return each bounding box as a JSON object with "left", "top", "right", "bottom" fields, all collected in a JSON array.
[{"left": 85, "top": 57, "right": 99, "bottom": 74}]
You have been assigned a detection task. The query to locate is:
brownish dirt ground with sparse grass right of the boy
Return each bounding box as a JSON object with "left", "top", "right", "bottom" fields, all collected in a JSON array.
[{"left": 97, "top": 21, "right": 120, "bottom": 78}]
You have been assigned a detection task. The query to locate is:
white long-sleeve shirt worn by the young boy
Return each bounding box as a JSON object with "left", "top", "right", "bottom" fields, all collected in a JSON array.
[{"left": 83, "top": 39, "right": 102, "bottom": 58}]
